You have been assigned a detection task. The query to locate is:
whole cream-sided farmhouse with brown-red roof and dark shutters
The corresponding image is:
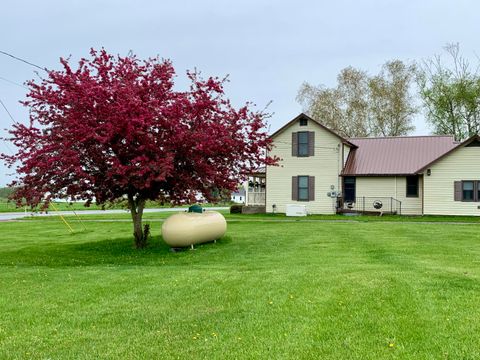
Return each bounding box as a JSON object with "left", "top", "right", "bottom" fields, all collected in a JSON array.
[{"left": 247, "top": 114, "right": 480, "bottom": 215}]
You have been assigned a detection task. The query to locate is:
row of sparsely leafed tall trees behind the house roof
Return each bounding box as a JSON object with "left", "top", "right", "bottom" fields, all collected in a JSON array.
[{"left": 297, "top": 44, "right": 480, "bottom": 140}]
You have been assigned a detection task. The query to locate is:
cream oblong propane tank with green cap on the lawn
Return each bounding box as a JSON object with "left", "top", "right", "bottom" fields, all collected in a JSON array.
[{"left": 162, "top": 211, "right": 227, "bottom": 248}]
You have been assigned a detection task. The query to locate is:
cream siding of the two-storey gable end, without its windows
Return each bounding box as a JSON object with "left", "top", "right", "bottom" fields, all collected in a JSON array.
[{"left": 266, "top": 121, "right": 343, "bottom": 214}]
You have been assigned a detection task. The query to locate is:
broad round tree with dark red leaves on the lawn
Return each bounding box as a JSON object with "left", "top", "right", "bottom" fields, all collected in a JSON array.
[{"left": 2, "top": 49, "right": 276, "bottom": 248}]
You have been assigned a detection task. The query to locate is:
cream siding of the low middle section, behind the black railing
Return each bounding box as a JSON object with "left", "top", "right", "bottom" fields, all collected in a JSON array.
[{"left": 356, "top": 176, "right": 423, "bottom": 215}]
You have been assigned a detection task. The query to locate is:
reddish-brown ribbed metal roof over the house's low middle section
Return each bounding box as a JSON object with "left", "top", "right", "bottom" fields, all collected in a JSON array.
[{"left": 342, "top": 136, "right": 458, "bottom": 176}]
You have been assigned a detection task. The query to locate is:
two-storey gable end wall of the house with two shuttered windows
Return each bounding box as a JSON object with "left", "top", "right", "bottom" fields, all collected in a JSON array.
[{"left": 266, "top": 114, "right": 348, "bottom": 214}]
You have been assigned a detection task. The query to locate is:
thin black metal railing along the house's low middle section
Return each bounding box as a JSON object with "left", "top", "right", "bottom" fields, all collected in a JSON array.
[{"left": 340, "top": 196, "right": 402, "bottom": 215}]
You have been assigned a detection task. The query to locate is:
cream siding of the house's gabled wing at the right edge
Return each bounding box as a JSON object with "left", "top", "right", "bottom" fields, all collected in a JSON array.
[{"left": 424, "top": 147, "right": 480, "bottom": 216}]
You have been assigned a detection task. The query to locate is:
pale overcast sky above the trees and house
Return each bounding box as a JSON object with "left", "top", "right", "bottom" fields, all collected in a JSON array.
[{"left": 0, "top": 0, "right": 480, "bottom": 186}]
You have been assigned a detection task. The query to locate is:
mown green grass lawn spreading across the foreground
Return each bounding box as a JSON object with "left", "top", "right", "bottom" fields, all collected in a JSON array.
[{"left": 0, "top": 214, "right": 480, "bottom": 359}]
